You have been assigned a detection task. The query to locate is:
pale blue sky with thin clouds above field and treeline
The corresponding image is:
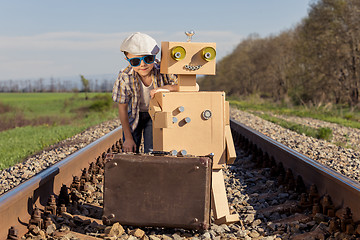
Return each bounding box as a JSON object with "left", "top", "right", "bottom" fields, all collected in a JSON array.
[{"left": 0, "top": 0, "right": 313, "bottom": 80}]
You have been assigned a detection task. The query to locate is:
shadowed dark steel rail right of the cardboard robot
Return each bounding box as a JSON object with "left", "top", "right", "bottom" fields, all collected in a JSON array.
[{"left": 230, "top": 120, "right": 360, "bottom": 221}]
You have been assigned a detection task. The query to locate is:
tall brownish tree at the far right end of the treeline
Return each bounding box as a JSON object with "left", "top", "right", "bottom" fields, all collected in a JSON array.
[{"left": 296, "top": 0, "right": 360, "bottom": 106}]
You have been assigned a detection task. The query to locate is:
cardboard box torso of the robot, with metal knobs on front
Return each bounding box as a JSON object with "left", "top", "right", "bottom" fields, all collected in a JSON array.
[{"left": 149, "top": 92, "right": 226, "bottom": 168}]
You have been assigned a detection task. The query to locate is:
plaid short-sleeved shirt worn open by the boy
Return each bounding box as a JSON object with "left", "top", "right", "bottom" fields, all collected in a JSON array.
[{"left": 112, "top": 63, "right": 177, "bottom": 131}]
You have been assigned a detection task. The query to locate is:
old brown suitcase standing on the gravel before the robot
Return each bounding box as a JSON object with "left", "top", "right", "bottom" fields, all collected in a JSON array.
[{"left": 103, "top": 154, "right": 212, "bottom": 230}]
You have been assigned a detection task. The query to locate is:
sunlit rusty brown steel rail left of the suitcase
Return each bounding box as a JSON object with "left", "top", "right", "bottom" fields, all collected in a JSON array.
[{"left": 0, "top": 127, "right": 122, "bottom": 239}]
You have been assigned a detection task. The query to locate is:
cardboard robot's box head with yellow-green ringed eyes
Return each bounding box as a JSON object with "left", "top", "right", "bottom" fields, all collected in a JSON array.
[{"left": 160, "top": 42, "right": 216, "bottom": 75}]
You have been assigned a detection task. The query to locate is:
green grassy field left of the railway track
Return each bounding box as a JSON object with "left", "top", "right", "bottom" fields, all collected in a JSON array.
[{"left": 0, "top": 93, "right": 117, "bottom": 169}]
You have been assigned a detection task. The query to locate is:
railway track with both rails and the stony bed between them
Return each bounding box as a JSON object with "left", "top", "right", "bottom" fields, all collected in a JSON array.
[{"left": 0, "top": 121, "right": 360, "bottom": 240}]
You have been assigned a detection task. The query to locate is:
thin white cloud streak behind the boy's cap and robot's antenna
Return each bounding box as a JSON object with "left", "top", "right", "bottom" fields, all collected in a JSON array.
[{"left": 0, "top": 31, "right": 242, "bottom": 51}]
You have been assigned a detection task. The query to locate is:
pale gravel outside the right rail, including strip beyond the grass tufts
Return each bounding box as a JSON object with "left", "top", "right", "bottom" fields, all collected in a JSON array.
[{"left": 230, "top": 108, "right": 360, "bottom": 182}]
